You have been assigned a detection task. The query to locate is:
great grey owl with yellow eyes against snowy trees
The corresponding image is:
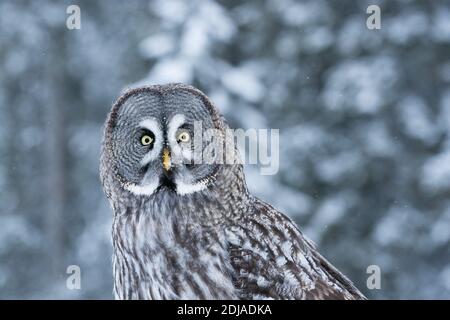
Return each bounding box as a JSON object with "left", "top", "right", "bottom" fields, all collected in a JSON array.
[{"left": 100, "top": 84, "right": 364, "bottom": 299}]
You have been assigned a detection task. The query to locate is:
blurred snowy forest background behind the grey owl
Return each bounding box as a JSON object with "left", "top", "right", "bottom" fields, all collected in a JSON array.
[{"left": 0, "top": 0, "right": 450, "bottom": 299}]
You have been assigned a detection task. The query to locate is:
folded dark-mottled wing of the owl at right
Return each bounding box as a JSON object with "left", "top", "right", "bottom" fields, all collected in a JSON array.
[{"left": 226, "top": 199, "right": 365, "bottom": 299}]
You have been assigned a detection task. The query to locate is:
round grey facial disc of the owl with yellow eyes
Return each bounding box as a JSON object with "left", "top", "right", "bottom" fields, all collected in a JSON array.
[{"left": 105, "top": 87, "right": 223, "bottom": 196}]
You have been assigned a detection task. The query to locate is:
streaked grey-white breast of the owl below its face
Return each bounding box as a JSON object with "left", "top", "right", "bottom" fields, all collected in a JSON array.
[{"left": 113, "top": 186, "right": 238, "bottom": 299}]
